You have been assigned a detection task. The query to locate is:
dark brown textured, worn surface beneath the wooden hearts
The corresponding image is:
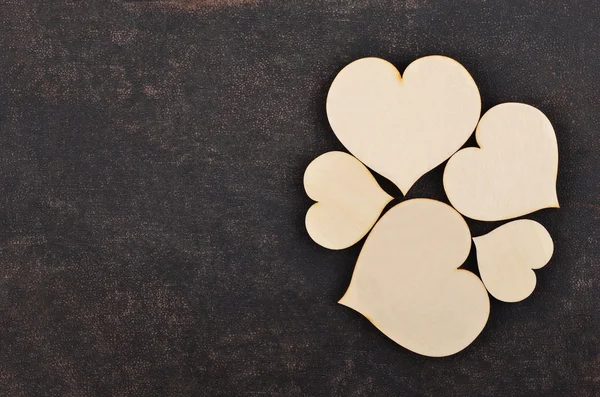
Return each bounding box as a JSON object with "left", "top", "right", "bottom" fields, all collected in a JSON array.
[{"left": 0, "top": 0, "right": 600, "bottom": 397}]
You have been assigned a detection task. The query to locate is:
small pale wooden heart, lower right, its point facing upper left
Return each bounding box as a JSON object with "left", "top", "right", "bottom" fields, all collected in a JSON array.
[{"left": 473, "top": 219, "right": 554, "bottom": 302}]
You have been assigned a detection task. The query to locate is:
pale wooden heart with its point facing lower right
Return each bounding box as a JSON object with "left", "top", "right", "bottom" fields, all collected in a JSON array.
[{"left": 444, "top": 103, "right": 558, "bottom": 221}]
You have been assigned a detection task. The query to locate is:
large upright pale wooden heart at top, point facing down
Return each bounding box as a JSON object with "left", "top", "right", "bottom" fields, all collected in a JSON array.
[{"left": 327, "top": 56, "right": 481, "bottom": 194}]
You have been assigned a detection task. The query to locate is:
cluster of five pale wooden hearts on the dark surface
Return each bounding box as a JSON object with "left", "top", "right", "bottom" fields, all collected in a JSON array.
[{"left": 304, "top": 56, "right": 558, "bottom": 357}]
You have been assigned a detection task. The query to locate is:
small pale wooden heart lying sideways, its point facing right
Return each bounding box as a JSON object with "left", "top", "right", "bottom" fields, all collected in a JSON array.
[{"left": 304, "top": 152, "right": 392, "bottom": 249}]
